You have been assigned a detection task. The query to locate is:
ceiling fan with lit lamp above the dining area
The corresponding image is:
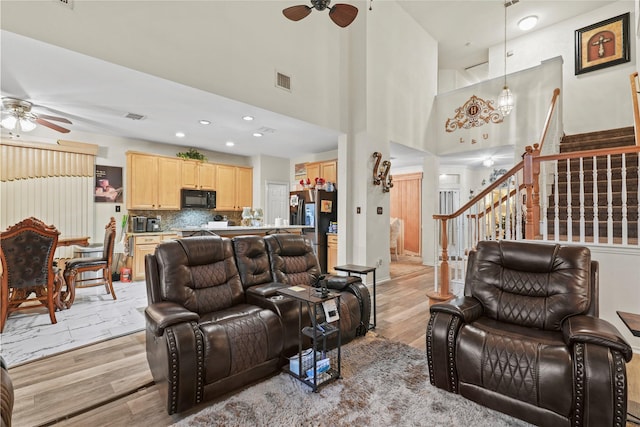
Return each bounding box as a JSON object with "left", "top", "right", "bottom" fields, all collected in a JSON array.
[{"left": 0, "top": 98, "right": 72, "bottom": 133}]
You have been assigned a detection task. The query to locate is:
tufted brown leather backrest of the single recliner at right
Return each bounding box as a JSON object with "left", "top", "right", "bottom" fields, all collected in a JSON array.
[{"left": 465, "top": 240, "right": 597, "bottom": 330}]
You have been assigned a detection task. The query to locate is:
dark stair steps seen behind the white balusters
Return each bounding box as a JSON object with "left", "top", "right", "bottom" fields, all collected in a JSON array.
[{"left": 547, "top": 127, "right": 638, "bottom": 242}]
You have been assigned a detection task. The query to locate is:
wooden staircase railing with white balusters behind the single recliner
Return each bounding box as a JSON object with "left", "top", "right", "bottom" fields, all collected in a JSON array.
[{"left": 428, "top": 85, "right": 640, "bottom": 302}]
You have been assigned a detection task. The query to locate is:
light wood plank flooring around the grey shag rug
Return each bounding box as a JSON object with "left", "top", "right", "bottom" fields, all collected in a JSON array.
[{"left": 9, "top": 257, "right": 640, "bottom": 427}]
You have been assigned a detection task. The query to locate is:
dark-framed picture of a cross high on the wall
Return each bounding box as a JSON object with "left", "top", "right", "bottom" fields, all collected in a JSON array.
[{"left": 575, "top": 12, "right": 631, "bottom": 75}]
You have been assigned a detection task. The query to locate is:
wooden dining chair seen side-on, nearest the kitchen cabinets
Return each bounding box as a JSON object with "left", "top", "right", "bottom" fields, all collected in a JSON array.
[{"left": 64, "top": 217, "right": 117, "bottom": 308}]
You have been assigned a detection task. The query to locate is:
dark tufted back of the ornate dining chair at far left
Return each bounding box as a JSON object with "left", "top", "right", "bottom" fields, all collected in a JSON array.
[{"left": 0, "top": 218, "right": 60, "bottom": 292}]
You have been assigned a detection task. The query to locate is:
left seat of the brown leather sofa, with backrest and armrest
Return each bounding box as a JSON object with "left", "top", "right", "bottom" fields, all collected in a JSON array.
[{"left": 145, "top": 236, "right": 283, "bottom": 414}]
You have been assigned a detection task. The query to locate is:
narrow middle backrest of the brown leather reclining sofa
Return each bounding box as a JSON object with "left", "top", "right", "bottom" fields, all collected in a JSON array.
[{"left": 232, "top": 235, "right": 271, "bottom": 289}]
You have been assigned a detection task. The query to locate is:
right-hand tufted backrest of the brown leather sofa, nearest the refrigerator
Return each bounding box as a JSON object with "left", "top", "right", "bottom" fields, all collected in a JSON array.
[{"left": 264, "top": 234, "right": 321, "bottom": 285}]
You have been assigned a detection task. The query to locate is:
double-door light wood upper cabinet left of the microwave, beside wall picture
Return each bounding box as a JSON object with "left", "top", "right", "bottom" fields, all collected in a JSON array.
[{"left": 126, "top": 153, "right": 182, "bottom": 210}]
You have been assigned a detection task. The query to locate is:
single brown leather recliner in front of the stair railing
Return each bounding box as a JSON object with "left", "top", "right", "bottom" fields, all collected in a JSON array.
[{"left": 427, "top": 241, "right": 632, "bottom": 427}]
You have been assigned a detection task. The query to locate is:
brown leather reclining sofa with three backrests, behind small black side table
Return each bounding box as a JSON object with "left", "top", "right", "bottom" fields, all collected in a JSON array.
[{"left": 145, "top": 234, "right": 371, "bottom": 414}]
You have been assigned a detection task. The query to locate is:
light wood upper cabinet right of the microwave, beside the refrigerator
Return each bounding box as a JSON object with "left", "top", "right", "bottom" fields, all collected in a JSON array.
[{"left": 216, "top": 165, "right": 253, "bottom": 211}]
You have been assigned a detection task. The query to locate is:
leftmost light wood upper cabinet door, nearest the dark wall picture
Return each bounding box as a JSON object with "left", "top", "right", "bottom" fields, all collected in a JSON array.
[{"left": 126, "top": 153, "right": 158, "bottom": 210}]
